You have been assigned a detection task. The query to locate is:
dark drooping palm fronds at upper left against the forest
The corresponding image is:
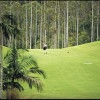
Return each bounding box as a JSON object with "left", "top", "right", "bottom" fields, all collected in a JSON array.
[{"left": 0, "top": 14, "right": 20, "bottom": 47}]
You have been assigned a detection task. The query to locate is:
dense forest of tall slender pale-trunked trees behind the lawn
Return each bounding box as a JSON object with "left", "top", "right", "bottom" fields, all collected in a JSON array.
[{"left": 0, "top": 0, "right": 100, "bottom": 49}]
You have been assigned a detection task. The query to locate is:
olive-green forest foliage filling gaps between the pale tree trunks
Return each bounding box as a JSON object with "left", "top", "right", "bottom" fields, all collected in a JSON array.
[{"left": 2, "top": 0, "right": 100, "bottom": 48}]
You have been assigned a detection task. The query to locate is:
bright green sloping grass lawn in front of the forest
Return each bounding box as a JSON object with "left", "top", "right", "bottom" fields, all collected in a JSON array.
[{"left": 2, "top": 41, "right": 100, "bottom": 99}]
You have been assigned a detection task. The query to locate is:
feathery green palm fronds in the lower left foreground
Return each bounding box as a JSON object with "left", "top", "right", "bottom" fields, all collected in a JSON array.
[{"left": 3, "top": 45, "right": 45, "bottom": 98}]
